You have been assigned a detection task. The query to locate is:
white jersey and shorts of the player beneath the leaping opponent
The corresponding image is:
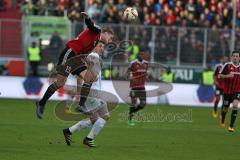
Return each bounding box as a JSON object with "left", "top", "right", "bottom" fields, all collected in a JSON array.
[{"left": 85, "top": 52, "right": 104, "bottom": 111}]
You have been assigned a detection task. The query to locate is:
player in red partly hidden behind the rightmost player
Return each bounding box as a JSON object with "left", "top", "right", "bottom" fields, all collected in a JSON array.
[{"left": 212, "top": 56, "right": 228, "bottom": 118}]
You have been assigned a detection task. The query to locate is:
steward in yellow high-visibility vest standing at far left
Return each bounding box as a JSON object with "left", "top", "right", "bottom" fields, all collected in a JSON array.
[{"left": 27, "top": 42, "right": 41, "bottom": 77}]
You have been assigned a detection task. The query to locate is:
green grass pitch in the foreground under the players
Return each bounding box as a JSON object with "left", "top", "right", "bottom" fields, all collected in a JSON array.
[{"left": 0, "top": 99, "right": 240, "bottom": 160}]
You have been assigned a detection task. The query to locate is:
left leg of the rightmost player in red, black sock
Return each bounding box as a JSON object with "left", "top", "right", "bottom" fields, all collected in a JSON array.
[{"left": 220, "top": 94, "right": 231, "bottom": 128}]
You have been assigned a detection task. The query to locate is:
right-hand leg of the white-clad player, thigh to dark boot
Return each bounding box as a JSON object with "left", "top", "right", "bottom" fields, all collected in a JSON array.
[{"left": 83, "top": 101, "right": 110, "bottom": 147}]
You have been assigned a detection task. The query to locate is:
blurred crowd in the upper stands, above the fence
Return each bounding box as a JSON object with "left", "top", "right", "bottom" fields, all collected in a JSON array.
[{"left": 14, "top": 0, "right": 240, "bottom": 28}]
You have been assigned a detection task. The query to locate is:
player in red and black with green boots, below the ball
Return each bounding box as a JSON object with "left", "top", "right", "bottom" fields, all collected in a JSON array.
[{"left": 128, "top": 52, "right": 148, "bottom": 125}]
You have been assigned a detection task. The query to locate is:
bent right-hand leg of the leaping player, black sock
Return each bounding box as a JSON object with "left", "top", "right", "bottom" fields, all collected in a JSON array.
[{"left": 76, "top": 70, "right": 97, "bottom": 112}]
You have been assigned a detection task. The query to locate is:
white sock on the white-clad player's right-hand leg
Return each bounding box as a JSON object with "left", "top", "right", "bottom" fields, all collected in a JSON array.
[{"left": 87, "top": 118, "right": 106, "bottom": 139}]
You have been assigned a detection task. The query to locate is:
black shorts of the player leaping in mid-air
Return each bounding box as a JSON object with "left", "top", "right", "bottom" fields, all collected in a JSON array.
[{"left": 56, "top": 47, "right": 87, "bottom": 76}]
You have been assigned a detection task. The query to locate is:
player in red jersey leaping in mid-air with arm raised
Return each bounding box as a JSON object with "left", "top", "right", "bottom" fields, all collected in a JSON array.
[{"left": 36, "top": 12, "right": 113, "bottom": 119}]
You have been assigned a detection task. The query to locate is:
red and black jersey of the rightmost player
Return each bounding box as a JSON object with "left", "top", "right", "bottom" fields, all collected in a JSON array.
[{"left": 221, "top": 62, "right": 240, "bottom": 94}]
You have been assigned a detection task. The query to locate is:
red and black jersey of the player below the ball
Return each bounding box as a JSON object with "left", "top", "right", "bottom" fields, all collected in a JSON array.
[{"left": 129, "top": 59, "right": 148, "bottom": 88}]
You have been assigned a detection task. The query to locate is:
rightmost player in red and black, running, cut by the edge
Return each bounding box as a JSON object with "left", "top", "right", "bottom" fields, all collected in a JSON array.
[{"left": 218, "top": 51, "right": 240, "bottom": 132}]
